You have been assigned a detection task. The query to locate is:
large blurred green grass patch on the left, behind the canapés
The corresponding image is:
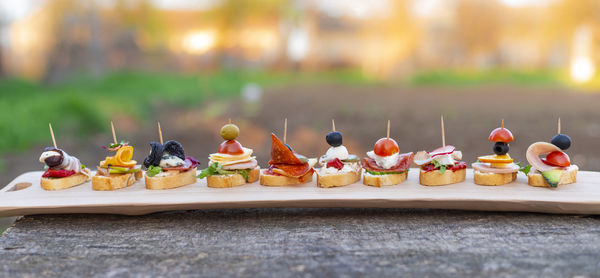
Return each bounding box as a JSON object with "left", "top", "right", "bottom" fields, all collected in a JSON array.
[{"left": 0, "top": 70, "right": 371, "bottom": 156}]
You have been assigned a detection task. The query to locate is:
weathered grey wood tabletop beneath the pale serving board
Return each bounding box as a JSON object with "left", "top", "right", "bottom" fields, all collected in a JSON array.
[{"left": 0, "top": 209, "right": 600, "bottom": 277}]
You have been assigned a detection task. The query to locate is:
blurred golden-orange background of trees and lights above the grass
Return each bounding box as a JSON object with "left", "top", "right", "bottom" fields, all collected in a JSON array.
[{"left": 2, "top": 0, "right": 600, "bottom": 83}]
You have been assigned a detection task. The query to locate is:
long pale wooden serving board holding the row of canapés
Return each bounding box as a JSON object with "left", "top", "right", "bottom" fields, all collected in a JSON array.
[{"left": 0, "top": 169, "right": 600, "bottom": 216}]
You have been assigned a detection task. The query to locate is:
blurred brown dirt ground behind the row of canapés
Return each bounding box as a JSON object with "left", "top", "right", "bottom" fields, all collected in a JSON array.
[{"left": 0, "top": 85, "right": 600, "bottom": 185}]
